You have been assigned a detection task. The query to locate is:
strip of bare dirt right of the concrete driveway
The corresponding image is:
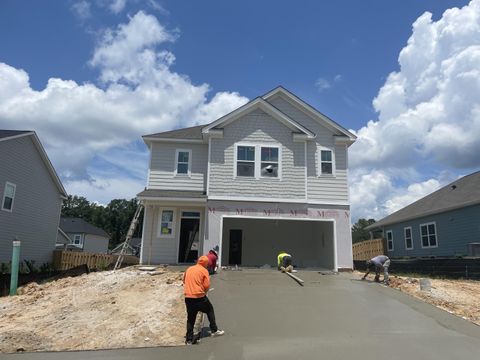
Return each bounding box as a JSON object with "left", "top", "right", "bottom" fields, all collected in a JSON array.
[{"left": 355, "top": 271, "right": 480, "bottom": 325}]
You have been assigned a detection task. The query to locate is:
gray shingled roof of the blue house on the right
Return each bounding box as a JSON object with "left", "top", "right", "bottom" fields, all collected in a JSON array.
[{"left": 366, "top": 171, "right": 480, "bottom": 230}]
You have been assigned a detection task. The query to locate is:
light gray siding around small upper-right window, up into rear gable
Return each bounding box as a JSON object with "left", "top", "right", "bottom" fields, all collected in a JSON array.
[{"left": 269, "top": 96, "right": 348, "bottom": 204}]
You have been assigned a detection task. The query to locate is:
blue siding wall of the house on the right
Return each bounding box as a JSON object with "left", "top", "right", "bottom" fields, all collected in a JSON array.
[{"left": 384, "top": 205, "right": 480, "bottom": 257}]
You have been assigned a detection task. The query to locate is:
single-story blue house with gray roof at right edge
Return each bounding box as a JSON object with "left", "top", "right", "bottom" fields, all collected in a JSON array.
[{"left": 366, "top": 172, "right": 480, "bottom": 257}]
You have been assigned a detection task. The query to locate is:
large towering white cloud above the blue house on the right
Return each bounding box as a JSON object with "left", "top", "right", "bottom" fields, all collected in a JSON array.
[{"left": 350, "top": 0, "right": 480, "bottom": 219}]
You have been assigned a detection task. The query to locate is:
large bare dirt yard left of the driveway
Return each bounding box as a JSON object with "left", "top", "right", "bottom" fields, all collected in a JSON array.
[{"left": 0, "top": 267, "right": 186, "bottom": 352}]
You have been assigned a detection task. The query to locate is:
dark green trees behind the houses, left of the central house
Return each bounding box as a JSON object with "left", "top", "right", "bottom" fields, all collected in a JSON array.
[{"left": 62, "top": 195, "right": 143, "bottom": 249}]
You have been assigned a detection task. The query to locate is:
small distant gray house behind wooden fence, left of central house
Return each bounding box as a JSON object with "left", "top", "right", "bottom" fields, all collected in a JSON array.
[{"left": 58, "top": 218, "right": 110, "bottom": 254}]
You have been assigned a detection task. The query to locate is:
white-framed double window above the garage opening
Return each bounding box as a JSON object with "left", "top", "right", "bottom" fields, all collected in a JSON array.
[{"left": 234, "top": 143, "right": 282, "bottom": 179}]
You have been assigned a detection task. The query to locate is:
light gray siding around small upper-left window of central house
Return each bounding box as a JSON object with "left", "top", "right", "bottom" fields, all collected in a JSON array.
[{"left": 148, "top": 142, "right": 208, "bottom": 191}]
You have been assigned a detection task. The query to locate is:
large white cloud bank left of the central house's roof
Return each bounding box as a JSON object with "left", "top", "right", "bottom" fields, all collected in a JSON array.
[{"left": 0, "top": 11, "right": 248, "bottom": 200}]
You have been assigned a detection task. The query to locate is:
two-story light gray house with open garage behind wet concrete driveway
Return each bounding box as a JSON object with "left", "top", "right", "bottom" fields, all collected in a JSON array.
[{"left": 138, "top": 87, "right": 356, "bottom": 270}]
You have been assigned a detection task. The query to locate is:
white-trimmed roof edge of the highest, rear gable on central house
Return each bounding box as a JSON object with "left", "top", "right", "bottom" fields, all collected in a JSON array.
[{"left": 262, "top": 86, "right": 357, "bottom": 142}]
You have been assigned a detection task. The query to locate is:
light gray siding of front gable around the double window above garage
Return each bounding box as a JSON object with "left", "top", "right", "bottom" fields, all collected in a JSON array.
[{"left": 209, "top": 110, "right": 305, "bottom": 199}]
